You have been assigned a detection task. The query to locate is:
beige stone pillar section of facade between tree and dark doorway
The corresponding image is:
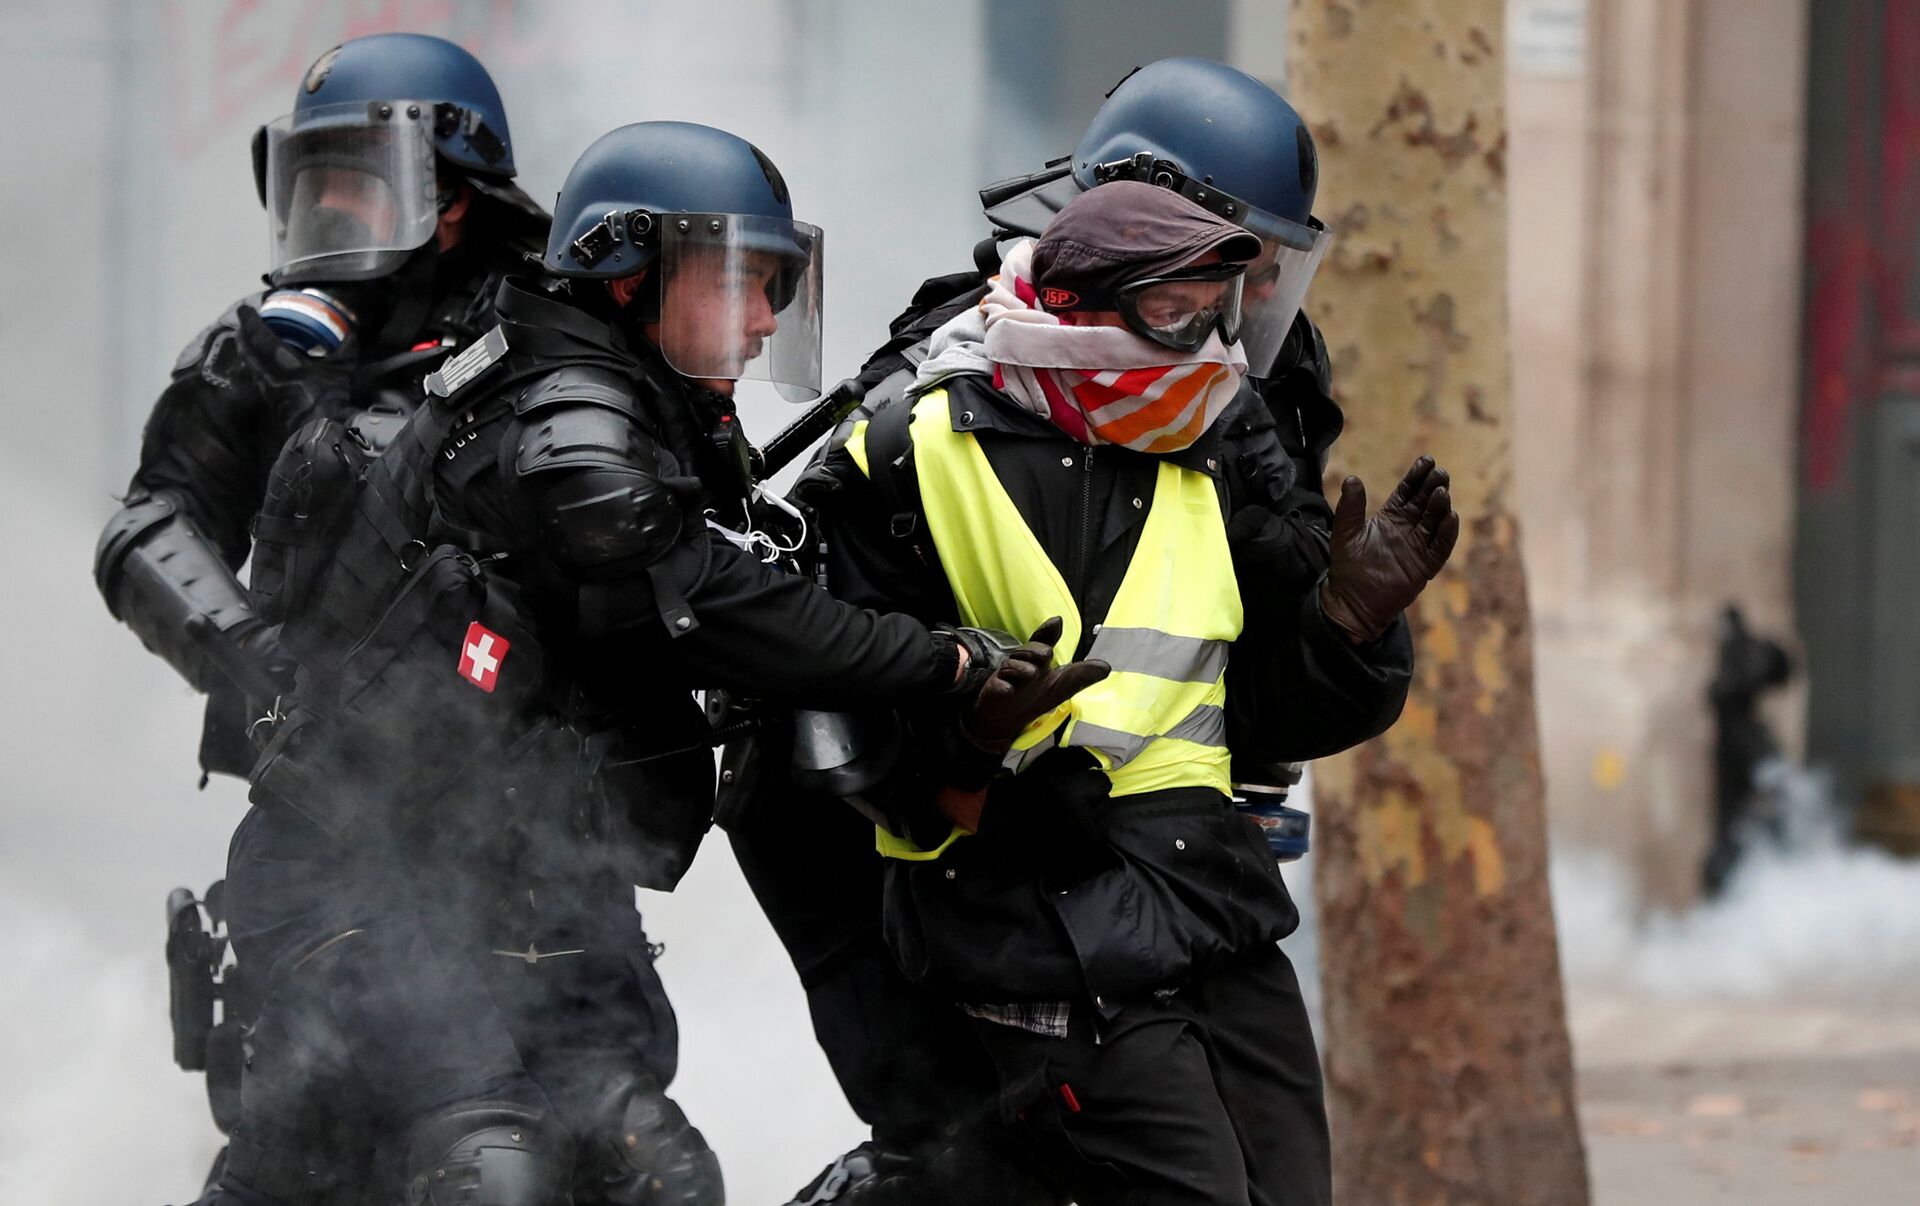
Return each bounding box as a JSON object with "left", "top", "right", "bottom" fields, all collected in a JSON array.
[{"left": 1509, "top": 0, "right": 1807, "bottom": 903}]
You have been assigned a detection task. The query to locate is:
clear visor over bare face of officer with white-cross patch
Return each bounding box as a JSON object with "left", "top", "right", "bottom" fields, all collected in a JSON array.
[{"left": 655, "top": 213, "right": 822, "bottom": 401}]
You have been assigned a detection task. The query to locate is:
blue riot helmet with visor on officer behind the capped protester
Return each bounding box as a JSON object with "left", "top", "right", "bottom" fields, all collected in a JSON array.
[{"left": 981, "top": 58, "right": 1329, "bottom": 376}]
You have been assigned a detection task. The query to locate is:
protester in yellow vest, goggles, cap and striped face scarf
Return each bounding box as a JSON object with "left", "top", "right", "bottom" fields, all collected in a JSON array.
[{"left": 806, "top": 181, "right": 1459, "bottom": 1206}]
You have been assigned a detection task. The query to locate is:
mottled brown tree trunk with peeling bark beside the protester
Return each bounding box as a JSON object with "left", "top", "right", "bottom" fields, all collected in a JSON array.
[{"left": 1288, "top": 0, "right": 1588, "bottom": 1206}]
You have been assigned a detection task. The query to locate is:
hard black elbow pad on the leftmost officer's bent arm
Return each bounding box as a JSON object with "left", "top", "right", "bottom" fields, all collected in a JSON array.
[{"left": 94, "top": 495, "right": 259, "bottom": 691}]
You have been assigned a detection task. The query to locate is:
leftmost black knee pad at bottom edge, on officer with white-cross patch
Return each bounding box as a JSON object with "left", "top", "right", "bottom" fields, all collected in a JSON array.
[{"left": 403, "top": 1100, "right": 574, "bottom": 1206}]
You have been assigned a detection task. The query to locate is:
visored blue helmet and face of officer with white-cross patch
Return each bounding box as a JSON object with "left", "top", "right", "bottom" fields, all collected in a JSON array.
[{"left": 543, "top": 121, "right": 822, "bottom": 401}]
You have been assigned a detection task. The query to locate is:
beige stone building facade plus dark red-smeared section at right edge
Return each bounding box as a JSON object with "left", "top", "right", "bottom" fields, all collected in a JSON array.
[{"left": 1509, "top": 0, "right": 1920, "bottom": 905}]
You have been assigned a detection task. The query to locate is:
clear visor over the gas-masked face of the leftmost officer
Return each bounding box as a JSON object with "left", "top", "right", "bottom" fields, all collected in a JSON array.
[{"left": 263, "top": 100, "right": 440, "bottom": 284}]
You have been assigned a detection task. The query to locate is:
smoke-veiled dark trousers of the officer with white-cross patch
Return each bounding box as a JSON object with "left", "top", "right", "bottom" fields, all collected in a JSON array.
[{"left": 208, "top": 807, "right": 680, "bottom": 1206}]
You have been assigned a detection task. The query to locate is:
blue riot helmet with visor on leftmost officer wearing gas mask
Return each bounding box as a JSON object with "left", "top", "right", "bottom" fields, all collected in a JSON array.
[{"left": 253, "top": 33, "right": 545, "bottom": 284}]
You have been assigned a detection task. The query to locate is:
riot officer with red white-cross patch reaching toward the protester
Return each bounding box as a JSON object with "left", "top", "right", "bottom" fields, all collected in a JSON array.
[{"left": 204, "top": 123, "right": 1104, "bottom": 1206}]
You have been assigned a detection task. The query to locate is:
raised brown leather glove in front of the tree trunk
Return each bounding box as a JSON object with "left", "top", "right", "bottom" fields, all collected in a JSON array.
[{"left": 1321, "top": 457, "right": 1459, "bottom": 643}]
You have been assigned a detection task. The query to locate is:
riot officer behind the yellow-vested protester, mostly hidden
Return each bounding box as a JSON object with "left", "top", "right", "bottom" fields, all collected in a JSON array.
[{"left": 728, "top": 58, "right": 1342, "bottom": 1204}]
